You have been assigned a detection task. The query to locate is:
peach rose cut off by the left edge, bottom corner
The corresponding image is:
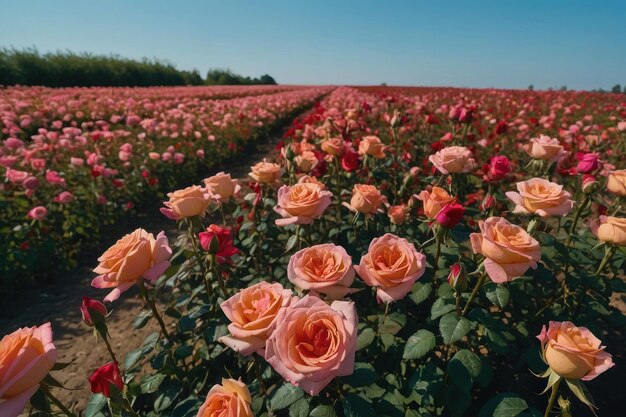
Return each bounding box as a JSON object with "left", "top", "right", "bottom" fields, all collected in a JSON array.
[{"left": 0, "top": 323, "right": 57, "bottom": 417}]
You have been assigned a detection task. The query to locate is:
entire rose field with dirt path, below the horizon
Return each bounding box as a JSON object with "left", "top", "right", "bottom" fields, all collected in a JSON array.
[{"left": 0, "top": 85, "right": 626, "bottom": 417}]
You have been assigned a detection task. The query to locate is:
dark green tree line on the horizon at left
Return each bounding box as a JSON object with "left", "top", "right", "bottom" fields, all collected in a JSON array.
[{"left": 0, "top": 48, "right": 276, "bottom": 87}]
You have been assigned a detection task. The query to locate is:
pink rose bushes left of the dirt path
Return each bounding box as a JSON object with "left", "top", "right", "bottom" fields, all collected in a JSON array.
[{"left": 0, "top": 83, "right": 326, "bottom": 290}]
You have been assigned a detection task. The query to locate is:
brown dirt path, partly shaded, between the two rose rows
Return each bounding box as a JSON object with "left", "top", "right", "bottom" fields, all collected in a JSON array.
[{"left": 0, "top": 116, "right": 283, "bottom": 411}]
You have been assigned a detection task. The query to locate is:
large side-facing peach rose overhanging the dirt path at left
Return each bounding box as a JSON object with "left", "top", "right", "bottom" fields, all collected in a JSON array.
[{"left": 91, "top": 229, "right": 172, "bottom": 301}]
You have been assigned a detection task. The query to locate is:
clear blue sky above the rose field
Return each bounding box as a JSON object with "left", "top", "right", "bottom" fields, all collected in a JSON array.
[{"left": 0, "top": 0, "right": 626, "bottom": 89}]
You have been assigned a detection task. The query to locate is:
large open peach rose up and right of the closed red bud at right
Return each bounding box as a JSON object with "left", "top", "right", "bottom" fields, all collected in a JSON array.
[{"left": 470, "top": 217, "right": 541, "bottom": 284}]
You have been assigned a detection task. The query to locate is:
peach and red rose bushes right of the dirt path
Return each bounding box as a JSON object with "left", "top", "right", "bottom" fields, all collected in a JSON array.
[{"left": 0, "top": 88, "right": 626, "bottom": 417}]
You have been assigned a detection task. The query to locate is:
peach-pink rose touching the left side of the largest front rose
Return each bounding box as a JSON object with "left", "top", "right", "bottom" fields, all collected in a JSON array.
[{"left": 219, "top": 281, "right": 292, "bottom": 356}]
